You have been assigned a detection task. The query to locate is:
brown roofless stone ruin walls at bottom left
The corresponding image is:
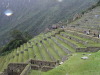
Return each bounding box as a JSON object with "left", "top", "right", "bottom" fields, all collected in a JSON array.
[{"left": 0, "top": 59, "right": 59, "bottom": 75}]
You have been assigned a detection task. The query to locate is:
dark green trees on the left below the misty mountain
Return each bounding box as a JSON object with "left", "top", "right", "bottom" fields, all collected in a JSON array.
[{"left": 0, "top": 30, "right": 32, "bottom": 55}]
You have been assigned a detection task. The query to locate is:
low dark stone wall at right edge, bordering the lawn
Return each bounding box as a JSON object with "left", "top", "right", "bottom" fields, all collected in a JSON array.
[{"left": 76, "top": 47, "right": 100, "bottom": 52}]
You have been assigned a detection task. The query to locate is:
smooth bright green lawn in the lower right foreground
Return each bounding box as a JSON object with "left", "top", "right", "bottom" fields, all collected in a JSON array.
[{"left": 42, "top": 52, "right": 100, "bottom": 75}]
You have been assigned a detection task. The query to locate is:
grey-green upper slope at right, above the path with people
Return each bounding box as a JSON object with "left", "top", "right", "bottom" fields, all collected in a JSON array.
[{"left": 69, "top": 6, "right": 100, "bottom": 31}]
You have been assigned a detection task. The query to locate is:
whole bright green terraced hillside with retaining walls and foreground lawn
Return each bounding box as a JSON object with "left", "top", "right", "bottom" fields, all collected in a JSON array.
[{"left": 0, "top": 28, "right": 100, "bottom": 75}]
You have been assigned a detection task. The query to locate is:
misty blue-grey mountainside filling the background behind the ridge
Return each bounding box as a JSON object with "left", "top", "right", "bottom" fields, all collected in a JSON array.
[{"left": 0, "top": 0, "right": 98, "bottom": 45}]
